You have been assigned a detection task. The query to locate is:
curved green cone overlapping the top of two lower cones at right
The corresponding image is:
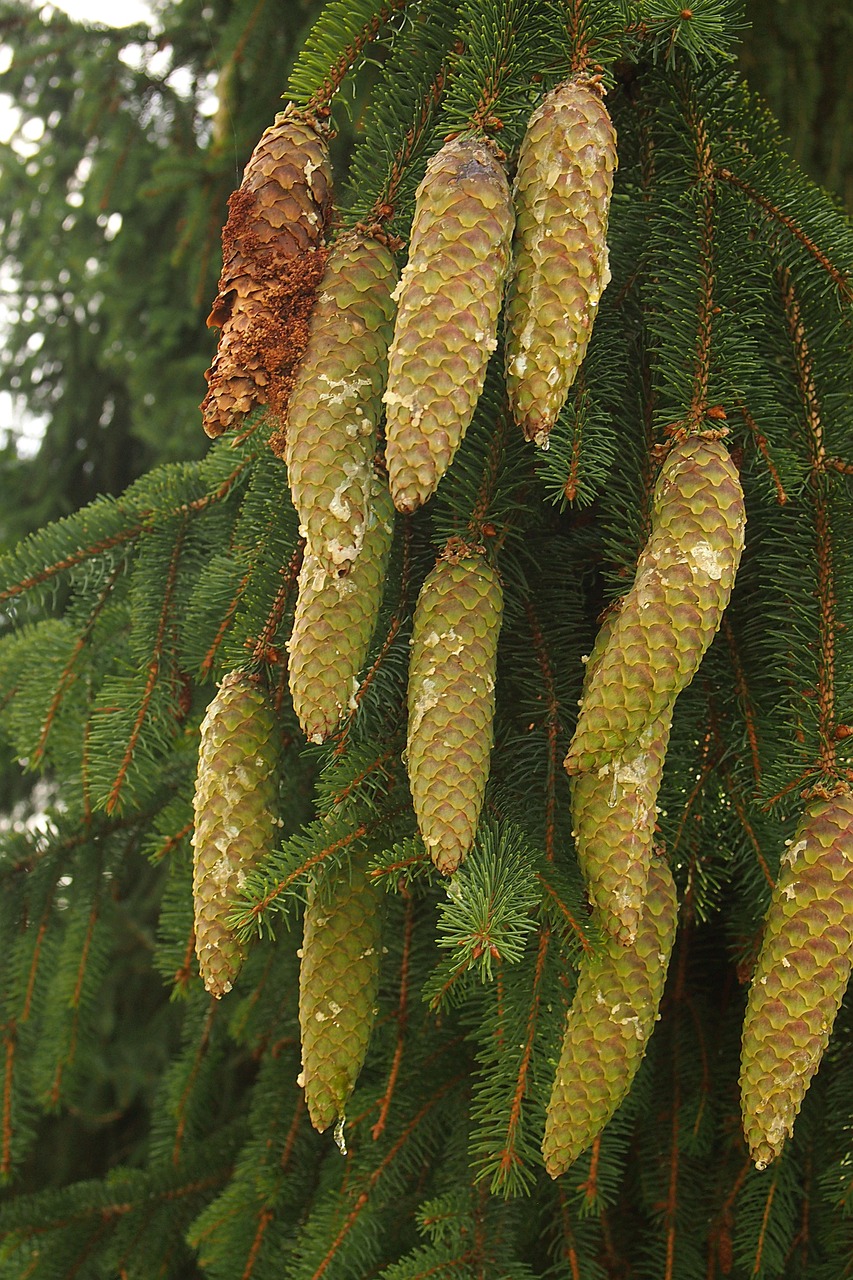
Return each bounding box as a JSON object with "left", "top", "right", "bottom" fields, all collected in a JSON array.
[{"left": 565, "top": 436, "right": 747, "bottom": 773}]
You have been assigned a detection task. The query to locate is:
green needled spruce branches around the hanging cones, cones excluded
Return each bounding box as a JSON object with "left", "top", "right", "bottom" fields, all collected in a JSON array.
[{"left": 0, "top": 0, "right": 853, "bottom": 1280}]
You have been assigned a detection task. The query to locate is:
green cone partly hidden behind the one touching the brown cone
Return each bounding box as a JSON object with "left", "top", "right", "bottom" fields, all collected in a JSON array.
[{"left": 287, "top": 479, "right": 394, "bottom": 742}]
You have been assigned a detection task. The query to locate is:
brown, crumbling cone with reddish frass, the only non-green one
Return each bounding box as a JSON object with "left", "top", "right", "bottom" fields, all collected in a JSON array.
[{"left": 201, "top": 108, "right": 332, "bottom": 436}]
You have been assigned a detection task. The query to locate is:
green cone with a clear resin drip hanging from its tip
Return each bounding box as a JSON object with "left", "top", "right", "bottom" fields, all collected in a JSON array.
[{"left": 298, "top": 856, "right": 382, "bottom": 1133}]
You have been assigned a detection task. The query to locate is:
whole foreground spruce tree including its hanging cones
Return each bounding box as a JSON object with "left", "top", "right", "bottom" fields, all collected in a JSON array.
[{"left": 0, "top": 0, "right": 853, "bottom": 1280}]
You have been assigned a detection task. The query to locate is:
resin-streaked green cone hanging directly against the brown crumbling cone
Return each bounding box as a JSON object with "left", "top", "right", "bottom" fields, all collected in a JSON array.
[{"left": 284, "top": 232, "right": 397, "bottom": 577}]
